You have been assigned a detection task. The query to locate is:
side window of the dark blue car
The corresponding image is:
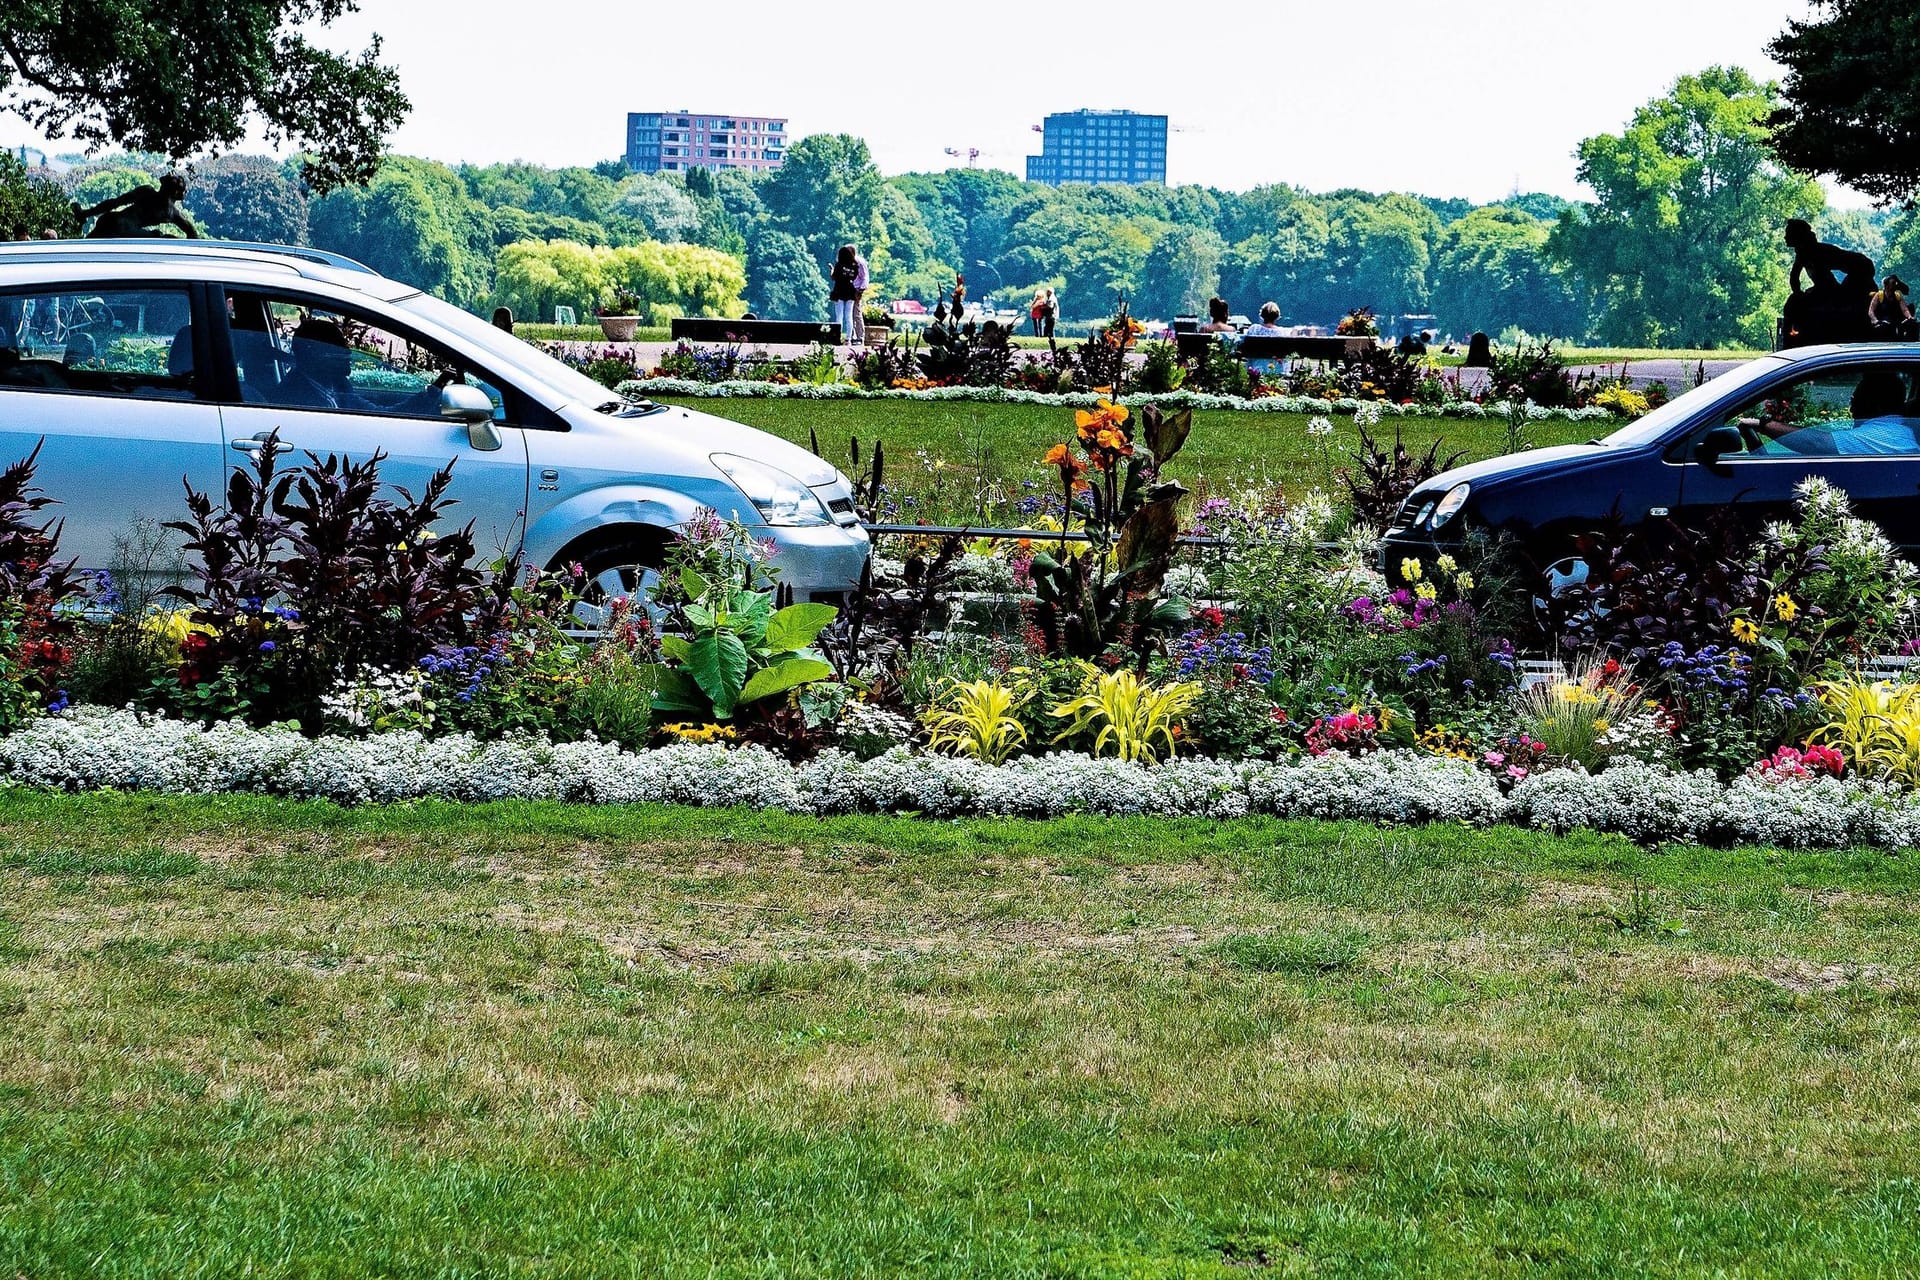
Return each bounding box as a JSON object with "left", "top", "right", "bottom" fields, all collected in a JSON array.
[{"left": 1722, "top": 363, "right": 1920, "bottom": 459}]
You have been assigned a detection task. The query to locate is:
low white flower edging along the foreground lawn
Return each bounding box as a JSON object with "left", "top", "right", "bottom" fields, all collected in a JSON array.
[{"left": 0, "top": 706, "right": 1920, "bottom": 850}]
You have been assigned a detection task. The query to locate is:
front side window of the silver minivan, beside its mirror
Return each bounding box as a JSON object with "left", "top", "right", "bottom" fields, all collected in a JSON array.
[{"left": 227, "top": 292, "right": 507, "bottom": 422}]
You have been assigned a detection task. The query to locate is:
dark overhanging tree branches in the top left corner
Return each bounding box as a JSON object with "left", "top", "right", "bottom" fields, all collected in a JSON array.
[{"left": 0, "top": 0, "right": 411, "bottom": 192}]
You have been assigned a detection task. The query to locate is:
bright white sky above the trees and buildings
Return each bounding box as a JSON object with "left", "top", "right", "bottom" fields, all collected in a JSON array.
[{"left": 11, "top": 0, "right": 1859, "bottom": 203}]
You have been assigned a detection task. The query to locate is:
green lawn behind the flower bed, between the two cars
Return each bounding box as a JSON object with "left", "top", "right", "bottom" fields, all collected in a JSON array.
[{"left": 660, "top": 397, "right": 1609, "bottom": 524}]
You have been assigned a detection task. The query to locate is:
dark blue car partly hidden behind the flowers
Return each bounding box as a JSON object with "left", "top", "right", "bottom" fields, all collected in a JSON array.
[{"left": 1382, "top": 344, "right": 1920, "bottom": 585}]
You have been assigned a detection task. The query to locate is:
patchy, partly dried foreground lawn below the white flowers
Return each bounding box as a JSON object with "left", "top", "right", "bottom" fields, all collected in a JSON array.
[{"left": 0, "top": 791, "right": 1920, "bottom": 1278}]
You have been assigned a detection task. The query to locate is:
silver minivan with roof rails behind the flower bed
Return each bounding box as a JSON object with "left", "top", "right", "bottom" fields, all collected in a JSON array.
[{"left": 0, "top": 240, "right": 870, "bottom": 601}]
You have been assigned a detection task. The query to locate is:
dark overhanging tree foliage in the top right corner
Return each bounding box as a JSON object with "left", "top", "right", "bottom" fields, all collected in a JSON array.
[{"left": 1768, "top": 0, "right": 1920, "bottom": 203}]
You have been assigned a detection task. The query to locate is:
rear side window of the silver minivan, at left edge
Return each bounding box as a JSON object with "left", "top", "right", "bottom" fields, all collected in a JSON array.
[{"left": 0, "top": 286, "right": 196, "bottom": 399}]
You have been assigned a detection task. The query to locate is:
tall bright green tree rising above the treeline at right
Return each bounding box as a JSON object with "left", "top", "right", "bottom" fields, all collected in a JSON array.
[{"left": 1548, "top": 67, "right": 1824, "bottom": 347}]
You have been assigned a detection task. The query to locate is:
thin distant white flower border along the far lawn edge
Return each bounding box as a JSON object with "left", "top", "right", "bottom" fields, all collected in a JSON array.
[{"left": 616, "top": 378, "right": 1626, "bottom": 424}]
